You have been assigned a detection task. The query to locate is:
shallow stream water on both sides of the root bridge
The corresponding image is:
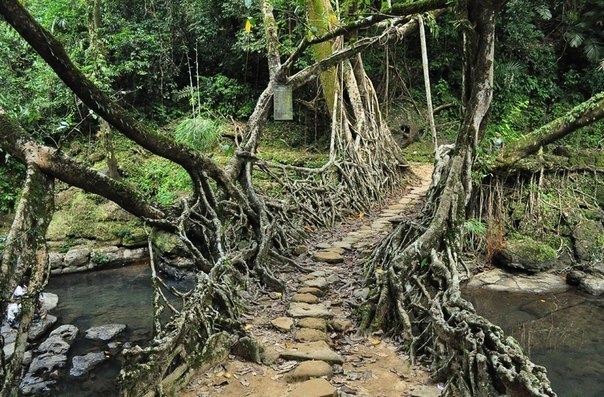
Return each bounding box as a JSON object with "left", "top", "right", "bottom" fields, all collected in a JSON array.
[{"left": 41, "top": 265, "right": 604, "bottom": 397}]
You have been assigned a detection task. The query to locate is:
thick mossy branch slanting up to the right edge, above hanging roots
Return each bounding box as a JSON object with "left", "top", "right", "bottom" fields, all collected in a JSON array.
[{"left": 492, "top": 92, "right": 604, "bottom": 172}]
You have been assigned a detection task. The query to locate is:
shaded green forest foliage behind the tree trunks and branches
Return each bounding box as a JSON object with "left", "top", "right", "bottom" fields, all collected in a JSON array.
[{"left": 0, "top": 0, "right": 604, "bottom": 212}]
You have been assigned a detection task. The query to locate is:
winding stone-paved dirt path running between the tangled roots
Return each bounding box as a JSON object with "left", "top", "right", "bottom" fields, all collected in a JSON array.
[{"left": 181, "top": 164, "right": 440, "bottom": 397}]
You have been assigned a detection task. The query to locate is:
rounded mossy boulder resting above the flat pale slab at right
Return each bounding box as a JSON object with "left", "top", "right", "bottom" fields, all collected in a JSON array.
[{"left": 493, "top": 237, "right": 557, "bottom": 273}]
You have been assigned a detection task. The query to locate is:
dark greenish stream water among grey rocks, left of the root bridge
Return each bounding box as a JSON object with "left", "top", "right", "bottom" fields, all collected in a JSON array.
[{"left": 46, "top": 265, "right": 190, "bottom": 397}]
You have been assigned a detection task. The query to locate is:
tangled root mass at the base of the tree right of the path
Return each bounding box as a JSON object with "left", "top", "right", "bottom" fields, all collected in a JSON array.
[{"left": 363, "top": 148, "right": 556, "bottom": 396}]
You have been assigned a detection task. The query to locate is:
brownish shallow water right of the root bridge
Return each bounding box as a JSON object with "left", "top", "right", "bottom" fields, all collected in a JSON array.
[{"left": 464, "top": 290, "right": 604, "bottom": 397}]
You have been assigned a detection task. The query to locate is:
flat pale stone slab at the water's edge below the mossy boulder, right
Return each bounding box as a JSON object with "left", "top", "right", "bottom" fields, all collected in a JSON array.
[{"left": 467, "top": 269, "right": 569, "bottom": 294}]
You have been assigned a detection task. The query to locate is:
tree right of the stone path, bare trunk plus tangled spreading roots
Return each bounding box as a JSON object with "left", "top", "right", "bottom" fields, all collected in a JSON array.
[{"left": 363, "top": 1, "right": 555, "bottom": 396}]
